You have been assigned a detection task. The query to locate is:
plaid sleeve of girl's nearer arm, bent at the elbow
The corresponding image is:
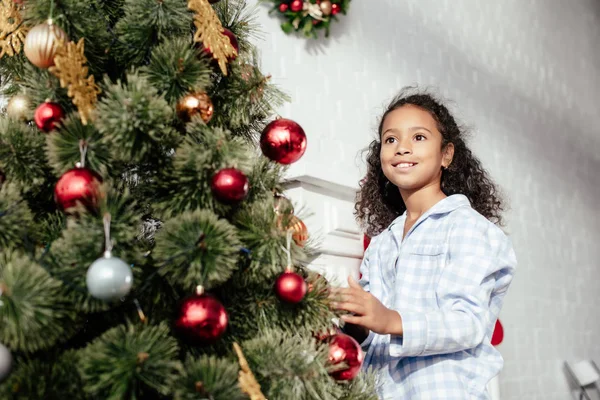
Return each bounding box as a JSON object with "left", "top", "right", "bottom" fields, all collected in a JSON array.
[{"left": 390, "top": 219, "right": 516, "bottom": 357}]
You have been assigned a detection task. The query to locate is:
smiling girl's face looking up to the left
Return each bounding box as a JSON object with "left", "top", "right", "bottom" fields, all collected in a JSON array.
[{"left": 380, "top": 104, "right": 454, "bottom": 192}]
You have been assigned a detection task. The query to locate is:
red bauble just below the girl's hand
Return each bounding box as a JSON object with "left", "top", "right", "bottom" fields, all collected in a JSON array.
[{"left": 329, "top": 333, "right": 364, "bottom": 381}]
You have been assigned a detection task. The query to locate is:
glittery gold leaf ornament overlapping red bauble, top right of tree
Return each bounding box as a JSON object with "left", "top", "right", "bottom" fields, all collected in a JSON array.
[{"left": 188, "top": 0, "right": 237, "bottom": 75}]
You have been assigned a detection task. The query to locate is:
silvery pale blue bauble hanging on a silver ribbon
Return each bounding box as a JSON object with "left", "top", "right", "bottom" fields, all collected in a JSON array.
[{"left": 86, "top": 251, "right": 133, "bottom": 301}]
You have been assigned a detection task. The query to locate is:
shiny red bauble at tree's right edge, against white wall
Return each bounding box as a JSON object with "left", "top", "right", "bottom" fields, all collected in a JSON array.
[{"left": 260, "top": 118, "right": 306, "bottom": 164}]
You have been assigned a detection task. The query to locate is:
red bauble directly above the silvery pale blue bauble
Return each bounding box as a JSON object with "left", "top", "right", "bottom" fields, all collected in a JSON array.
[{"left": 54, "top": 168, "right": 102, "bottom": 210}]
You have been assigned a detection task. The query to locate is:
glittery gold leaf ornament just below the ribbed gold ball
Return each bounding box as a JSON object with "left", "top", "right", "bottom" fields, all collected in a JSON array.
[{"left": 49, "top": 38, "right": 100, "bottom": 125}]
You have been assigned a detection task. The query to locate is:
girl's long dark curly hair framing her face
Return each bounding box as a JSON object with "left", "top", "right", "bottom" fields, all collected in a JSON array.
[{"left": 354, "top": 87, "right": 504, "bottom": 237}]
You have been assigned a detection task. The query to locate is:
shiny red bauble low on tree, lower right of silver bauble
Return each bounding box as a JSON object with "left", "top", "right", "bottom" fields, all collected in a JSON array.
[{"left": 175, "top": 294, "right": 229, "bottom": 344}]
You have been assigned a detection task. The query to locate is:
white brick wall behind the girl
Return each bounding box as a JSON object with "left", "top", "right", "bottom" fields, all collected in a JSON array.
[{"left": 249, "top": 0, "right": 600, "bottom": 399}]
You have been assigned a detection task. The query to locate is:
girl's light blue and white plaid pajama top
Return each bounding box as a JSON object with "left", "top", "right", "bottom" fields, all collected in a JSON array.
[{"left": 360, "top": 195, "right": 516, "bottom": 400}]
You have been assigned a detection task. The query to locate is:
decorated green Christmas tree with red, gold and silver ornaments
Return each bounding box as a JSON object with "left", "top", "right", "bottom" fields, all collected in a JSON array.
[{"left": 0, "top": 0, "right": 376, "bottom": 400}]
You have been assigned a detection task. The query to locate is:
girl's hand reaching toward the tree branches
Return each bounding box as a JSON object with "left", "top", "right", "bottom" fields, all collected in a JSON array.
[{"left": 331, "top": 277, "right": 402, "bottom": 335}]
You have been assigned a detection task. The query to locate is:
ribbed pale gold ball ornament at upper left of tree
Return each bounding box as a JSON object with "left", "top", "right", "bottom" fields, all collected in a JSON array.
[{"left": 24, "top": 19, "right": 69, "bottom": 69}]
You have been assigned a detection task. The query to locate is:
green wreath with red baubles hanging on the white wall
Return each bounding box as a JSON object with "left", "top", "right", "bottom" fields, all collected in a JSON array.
[{"left": 263, "top": 0, "right": 350, "bottom": 39}]
